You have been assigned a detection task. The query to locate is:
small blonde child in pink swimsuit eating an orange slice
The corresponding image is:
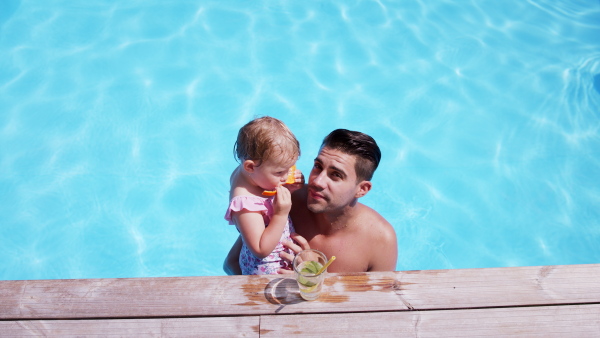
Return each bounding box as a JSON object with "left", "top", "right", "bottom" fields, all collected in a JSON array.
[{"left": 225, "top": 116, "right": 301, "bottom": 275}]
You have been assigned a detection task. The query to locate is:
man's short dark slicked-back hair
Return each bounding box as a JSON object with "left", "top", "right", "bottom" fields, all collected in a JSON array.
[{"left": 321, "top": 129, "right": 381, "bottom": 182}]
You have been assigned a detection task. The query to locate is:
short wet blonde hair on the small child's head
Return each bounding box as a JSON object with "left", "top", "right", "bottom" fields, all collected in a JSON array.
[{"left": 233, "top": 116, "right": 300, "bottom": 165}]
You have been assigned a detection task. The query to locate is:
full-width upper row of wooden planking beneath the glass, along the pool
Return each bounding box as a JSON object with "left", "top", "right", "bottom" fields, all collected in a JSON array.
[{"left": 0, "top": 264, "right": 600, "bottom": 320}]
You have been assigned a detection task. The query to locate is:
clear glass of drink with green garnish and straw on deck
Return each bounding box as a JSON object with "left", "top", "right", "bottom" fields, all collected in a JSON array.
[{"left": 293, "top": 249, "right": 327, "bottom": 300}]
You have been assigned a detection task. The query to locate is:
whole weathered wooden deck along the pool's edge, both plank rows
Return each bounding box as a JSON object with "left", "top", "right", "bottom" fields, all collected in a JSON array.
[{"left": 0, "top": 264, "right": 600, "bottom": 337}]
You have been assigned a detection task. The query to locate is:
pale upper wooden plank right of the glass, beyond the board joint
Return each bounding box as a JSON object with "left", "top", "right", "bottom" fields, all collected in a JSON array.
[{"left": 398, "top": 264, "right": 600, "bottom": 309}]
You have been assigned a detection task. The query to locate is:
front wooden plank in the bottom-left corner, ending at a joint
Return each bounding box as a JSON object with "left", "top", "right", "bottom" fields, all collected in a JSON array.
[{"left": 0, "top": 316, "right": 260, "bottom": 338}]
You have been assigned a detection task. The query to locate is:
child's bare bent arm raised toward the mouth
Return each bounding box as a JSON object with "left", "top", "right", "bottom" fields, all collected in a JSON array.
[{"left": 233, "top": 186, "right": 292, "bottom": 259}]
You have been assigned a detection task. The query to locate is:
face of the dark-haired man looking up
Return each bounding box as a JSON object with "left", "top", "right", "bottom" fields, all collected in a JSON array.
[{"left": 307, "top": 147, "right": 359, "bottom": 213}]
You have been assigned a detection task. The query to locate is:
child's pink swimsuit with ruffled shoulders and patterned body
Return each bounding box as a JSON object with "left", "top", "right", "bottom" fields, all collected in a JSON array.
[{"left": 225, "top": 196, "right": 295, "bottom": 275}]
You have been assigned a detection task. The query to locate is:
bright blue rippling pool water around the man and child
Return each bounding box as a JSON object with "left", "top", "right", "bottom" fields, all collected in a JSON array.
[{"left": 0, "top": 0, "right": 600, "bottom": 279}]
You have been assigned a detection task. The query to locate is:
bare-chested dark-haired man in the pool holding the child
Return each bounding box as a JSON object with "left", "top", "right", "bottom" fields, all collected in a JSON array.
[{"left": 223, "top": 129, "right": 398, "bottom": 275}]
